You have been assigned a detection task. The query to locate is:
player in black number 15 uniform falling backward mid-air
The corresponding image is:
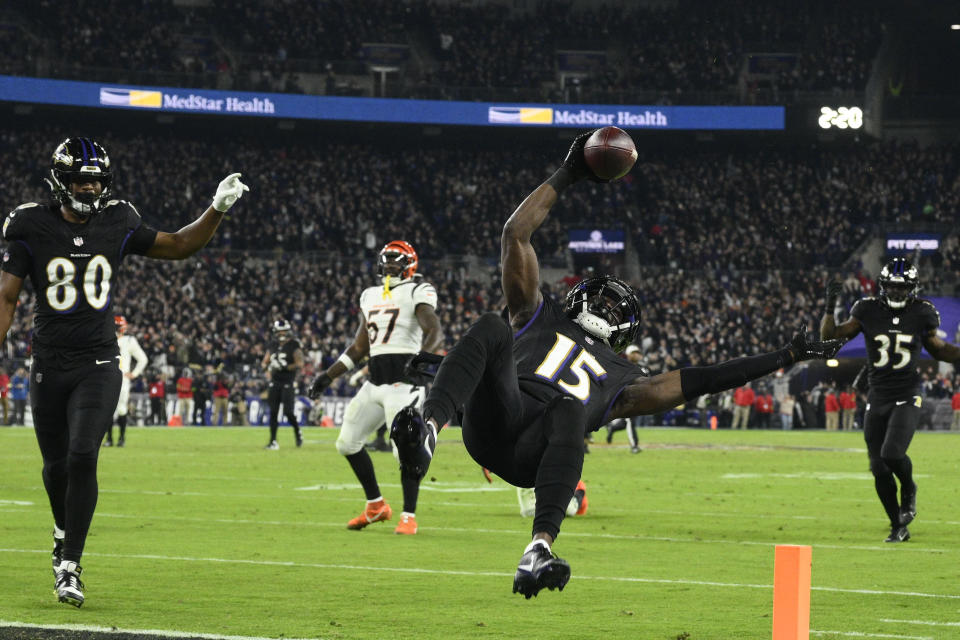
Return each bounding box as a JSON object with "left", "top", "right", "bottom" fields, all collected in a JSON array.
[{"left": 391, "top": 134, "right": 839, "bottom": 598}]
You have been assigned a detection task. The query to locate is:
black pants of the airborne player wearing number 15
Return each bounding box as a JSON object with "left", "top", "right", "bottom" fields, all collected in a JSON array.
[{"left": 424, "top": 313, "right": 586, "bottom": 538}]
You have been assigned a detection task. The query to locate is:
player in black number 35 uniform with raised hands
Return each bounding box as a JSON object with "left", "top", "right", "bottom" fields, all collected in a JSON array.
[{"left": 820, "top": 258, "right": 960, "bottom": 542}]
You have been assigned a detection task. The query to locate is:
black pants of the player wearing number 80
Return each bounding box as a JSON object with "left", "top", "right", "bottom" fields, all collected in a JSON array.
[{"left": 30, "top": 355, "right": 123, "bottom": 562}]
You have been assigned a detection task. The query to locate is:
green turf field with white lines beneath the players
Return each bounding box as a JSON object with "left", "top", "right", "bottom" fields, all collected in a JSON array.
[{"left": 0, "top": 428, "right": 960, "bottom": 640}]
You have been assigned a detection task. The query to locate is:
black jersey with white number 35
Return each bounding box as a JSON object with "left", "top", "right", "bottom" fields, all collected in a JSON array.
[{"left": 850, "top": 297, "right": 940, "bottom": 396}]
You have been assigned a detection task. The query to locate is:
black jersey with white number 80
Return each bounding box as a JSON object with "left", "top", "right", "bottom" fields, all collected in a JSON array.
[{"left": 0, "top": 200, "right": 157, "bottom": 367}]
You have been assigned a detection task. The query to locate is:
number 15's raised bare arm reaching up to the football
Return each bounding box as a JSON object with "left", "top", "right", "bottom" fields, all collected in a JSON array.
[{"left": 500, "top": 131, "right": 593, "bottom": 326}]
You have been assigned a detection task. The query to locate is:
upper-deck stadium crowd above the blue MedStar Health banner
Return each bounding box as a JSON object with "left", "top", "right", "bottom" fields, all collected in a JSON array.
[{"left": 0, "top": 0, "right": 884, "bottom": 103}]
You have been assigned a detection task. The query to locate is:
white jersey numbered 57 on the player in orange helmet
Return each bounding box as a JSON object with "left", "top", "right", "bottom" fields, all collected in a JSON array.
[{"left": 360, "top": 276, "right": 437, "bottom": 384}]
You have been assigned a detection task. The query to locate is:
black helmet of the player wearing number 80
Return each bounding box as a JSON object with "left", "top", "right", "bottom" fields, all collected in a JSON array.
[{"left": 48, "top": 138, "right": 113, "bottom": 218}]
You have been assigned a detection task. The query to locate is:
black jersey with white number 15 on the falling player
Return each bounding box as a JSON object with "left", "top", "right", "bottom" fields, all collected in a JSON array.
[{"left": 513, "top": 297, "right": 645, "bottom": 431}]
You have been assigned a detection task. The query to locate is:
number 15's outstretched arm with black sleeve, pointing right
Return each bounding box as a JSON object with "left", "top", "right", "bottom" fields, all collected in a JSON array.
[{"left": 610, "top": 328, "right": 843, "bottom": 419}]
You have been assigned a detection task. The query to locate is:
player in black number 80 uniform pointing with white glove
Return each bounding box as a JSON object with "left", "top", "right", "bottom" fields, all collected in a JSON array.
[{"left": 0, "top": 138, "right": 247, "bottom": 607}]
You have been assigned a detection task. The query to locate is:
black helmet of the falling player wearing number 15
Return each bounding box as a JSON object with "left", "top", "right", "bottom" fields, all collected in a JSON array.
[{"left": 563, "top": 276, "right": 640, "bottom": 353}]
